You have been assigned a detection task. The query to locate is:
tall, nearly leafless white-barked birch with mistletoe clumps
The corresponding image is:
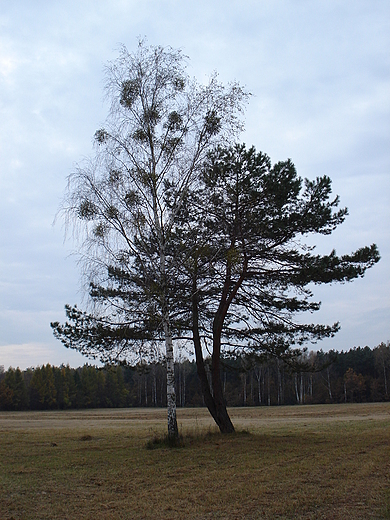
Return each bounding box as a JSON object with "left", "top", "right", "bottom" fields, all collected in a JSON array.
[{"left": 52, "top": 41, "right": 248, "bottom": 437}]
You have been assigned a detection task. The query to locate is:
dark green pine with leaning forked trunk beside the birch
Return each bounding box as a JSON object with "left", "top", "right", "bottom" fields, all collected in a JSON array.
[{"left": 165, "top": 144, "right": 379, "bottom": 431}]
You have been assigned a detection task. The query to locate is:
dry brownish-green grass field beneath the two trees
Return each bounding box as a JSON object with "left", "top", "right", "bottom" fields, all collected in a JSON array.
[{"left": 0, "top": 403, "right": 390, "bottom": 520}]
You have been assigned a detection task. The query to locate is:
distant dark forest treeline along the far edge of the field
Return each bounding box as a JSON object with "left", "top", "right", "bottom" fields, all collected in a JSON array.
[{"left": 0, "top": 343, "right": 390, "bottom": 410}]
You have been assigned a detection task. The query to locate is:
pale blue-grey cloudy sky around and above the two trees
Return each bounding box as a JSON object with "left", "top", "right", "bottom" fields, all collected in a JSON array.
[{"left": 0, "top": 0, "right": 390, "bottom": 369}]
